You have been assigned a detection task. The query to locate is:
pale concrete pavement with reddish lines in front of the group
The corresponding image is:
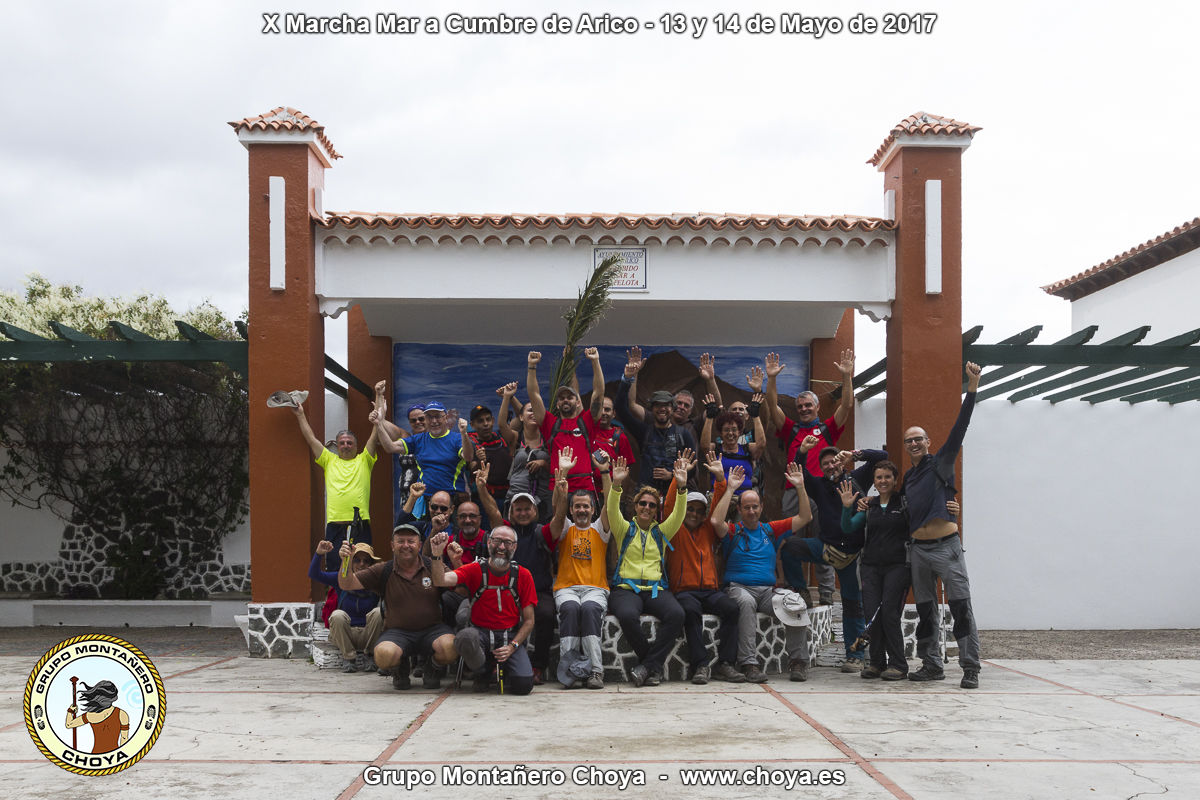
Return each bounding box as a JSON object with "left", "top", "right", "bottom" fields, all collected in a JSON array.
[{"left": 0, "top": 651, "right": 1200, "bottom": 800}]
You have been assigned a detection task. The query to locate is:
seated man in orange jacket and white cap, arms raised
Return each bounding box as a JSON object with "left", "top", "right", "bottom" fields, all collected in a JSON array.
[{"left": 662, "top": 452, "right": 745, "bottom": 684}]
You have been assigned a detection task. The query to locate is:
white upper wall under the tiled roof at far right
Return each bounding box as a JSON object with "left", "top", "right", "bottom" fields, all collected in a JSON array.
[{"left": 1070, "top": 249, "right": 1200, "bottom": 344}]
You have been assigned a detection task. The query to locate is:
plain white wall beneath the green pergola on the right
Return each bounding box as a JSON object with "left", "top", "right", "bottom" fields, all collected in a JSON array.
[{"left": 856, "top": 398, "right": 1200, "bottom": 630}]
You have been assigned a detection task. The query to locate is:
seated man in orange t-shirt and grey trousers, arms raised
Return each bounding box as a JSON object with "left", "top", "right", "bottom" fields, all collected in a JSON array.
[{"left": 550, "top": 451, "right": 612, "bottom": 688}]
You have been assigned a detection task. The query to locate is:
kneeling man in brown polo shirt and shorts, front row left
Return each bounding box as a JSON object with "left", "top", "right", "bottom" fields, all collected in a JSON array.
[{"left": 337, "top": 525, "right": 458, "bottom": 688}]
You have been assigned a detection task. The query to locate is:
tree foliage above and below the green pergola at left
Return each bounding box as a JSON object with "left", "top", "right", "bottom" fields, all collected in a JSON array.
[{"left": 0, "top": 276, "right": 248, "bottom": 596}]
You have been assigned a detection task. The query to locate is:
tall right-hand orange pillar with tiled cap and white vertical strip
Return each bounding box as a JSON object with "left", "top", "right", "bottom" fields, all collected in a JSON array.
[{"left": 872, "top": 114, "right": 979, "bottom": 475}]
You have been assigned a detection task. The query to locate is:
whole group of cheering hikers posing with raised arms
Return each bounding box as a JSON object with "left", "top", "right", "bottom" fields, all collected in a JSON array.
[{"left": 283, "top": 348, "right": 980, "bottom": 694}]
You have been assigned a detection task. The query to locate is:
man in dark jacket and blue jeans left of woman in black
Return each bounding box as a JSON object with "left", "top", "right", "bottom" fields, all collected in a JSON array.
[{"left": 780, "top": 435, "right": 888, "bottom": 673}]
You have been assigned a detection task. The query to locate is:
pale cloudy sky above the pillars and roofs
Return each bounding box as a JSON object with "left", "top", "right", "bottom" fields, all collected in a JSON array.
[{"left": 0, "top": 0, "right": 1200, "bottom": 357}]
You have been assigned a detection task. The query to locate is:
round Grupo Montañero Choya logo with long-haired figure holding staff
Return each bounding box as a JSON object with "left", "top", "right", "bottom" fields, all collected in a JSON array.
[{"left": 25, "top": 633, "right": 167, "bottom": 775}]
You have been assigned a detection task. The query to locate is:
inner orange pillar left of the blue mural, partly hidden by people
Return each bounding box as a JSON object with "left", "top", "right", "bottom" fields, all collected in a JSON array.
[{"left": 346, "top": 306, "right": 396, "bottom": 559}]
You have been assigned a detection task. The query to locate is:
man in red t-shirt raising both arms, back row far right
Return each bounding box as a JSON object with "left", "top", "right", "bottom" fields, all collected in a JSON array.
[{"left": 763, "top": 349, "right": 854, "bottom": 603}]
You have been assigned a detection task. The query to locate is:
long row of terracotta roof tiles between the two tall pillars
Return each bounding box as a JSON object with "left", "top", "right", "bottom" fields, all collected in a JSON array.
[{"left": 317, "top": 211, "right": 896, "bottom": 231}]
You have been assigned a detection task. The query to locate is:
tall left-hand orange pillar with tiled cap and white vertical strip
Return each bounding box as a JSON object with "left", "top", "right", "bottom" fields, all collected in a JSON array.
[{"left": 230, "top": 109, "right": 336, "bottom": 603}]
